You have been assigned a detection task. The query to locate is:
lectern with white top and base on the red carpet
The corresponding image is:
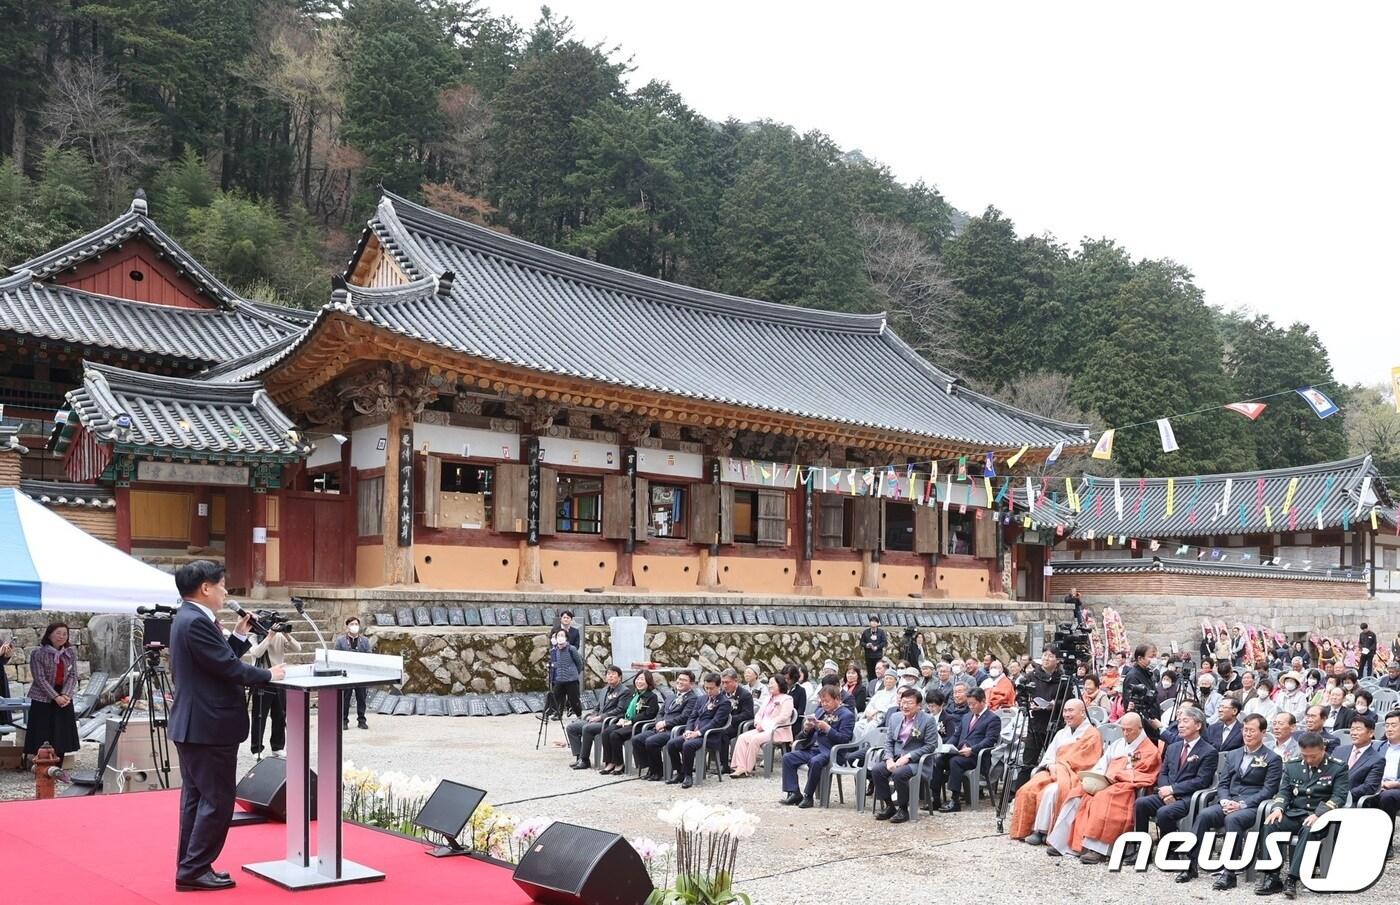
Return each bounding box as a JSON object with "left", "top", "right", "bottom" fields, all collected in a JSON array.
[{"left": 244, "top": 650, "right": 403, "bottom": 891}]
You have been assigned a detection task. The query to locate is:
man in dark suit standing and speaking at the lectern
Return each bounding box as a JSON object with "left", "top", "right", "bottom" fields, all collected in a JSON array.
[{"left": 168, "top": 559, "right": 281, "bottom": 891}]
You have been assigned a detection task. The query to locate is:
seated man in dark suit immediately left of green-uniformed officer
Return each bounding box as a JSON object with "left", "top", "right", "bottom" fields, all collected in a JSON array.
[{"left": 1176, "top": 713, "right": 1284, "bottom": 890}]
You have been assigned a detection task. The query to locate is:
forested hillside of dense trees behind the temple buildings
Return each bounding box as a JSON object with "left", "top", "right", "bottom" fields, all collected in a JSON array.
[{"left": 0, "top": 0, "right": 1400, "bottom": 474}]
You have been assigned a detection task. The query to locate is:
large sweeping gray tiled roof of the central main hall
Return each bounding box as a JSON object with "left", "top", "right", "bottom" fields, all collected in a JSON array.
[{"left": 324, "top": 195, "right": 1085, "bottom": 448}]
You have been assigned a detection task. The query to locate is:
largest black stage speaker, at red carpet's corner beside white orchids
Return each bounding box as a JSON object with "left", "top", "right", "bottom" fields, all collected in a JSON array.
[{"left": 515, "top": 824, "right": 651, "bottom": 905}]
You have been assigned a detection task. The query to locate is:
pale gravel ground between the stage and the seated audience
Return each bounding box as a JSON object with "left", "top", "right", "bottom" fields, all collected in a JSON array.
[{"left": 0, "top": 716, "right": 1400, "bottom": 905}]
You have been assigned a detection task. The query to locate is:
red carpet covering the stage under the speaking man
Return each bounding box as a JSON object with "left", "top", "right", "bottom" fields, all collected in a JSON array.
[{"left": 0, "top": 792, "right": 531, "bottom": 905}]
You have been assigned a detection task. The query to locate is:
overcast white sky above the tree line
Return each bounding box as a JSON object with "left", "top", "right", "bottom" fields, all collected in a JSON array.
[{"left": 487, "top": 0, "right": 1400, "bottom": 382}]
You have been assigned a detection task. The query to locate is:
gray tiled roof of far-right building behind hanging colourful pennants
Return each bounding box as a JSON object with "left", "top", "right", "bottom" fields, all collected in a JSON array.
[{"left": 1074, "top": 455, "right": 1392, "bottom": 538}]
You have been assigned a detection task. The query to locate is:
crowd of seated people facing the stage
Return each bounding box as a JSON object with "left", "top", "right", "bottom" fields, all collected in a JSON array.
[{"left": 551, "top": 627, "right": 1400, "bottom": 895}]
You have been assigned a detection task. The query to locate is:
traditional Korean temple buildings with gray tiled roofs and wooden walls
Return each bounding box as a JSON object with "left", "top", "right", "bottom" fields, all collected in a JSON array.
[{"left": 0, "top": 195, "right": 1393, "bottom": 610}]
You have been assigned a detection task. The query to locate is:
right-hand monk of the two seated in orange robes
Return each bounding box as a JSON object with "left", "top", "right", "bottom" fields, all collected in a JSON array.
[{"left": 1050, "top": 713, "right": 1162, "bottom": 864}]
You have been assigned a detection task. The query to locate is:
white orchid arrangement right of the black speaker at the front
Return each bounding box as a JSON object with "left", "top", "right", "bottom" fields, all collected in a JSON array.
[{"left": 638, "top": 799, "right": 759, "bottom": 905}]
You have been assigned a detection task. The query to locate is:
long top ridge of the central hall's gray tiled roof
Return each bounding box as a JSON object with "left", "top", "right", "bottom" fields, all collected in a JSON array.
[{"left": 371, "top": 192, "right": 886, "bottom": 335}]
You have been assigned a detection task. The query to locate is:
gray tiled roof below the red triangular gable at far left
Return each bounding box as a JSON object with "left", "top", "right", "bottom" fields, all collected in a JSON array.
[{"left": 0, "top": 270, "right": 300, "bottom": 363}]
